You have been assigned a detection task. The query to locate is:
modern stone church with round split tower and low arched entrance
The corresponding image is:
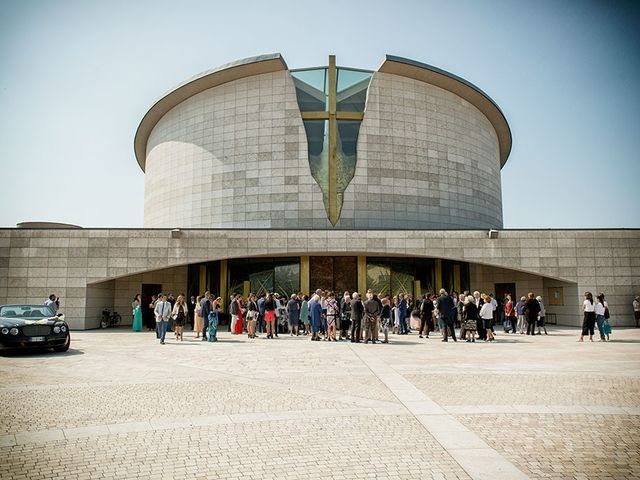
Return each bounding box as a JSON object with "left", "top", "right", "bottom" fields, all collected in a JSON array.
[{"left": 0, "top": 54, "right": 640, "bottom": 329}]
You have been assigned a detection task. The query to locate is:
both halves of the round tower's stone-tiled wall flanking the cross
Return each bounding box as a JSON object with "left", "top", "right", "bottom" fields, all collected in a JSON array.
[{"left": 144, "top": 62, "right": 502, "bottom": 229}]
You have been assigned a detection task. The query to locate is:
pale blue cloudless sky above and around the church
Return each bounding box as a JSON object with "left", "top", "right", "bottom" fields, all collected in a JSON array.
[{"left": 0, "top": 0, "right": 640, "bottom": 228}]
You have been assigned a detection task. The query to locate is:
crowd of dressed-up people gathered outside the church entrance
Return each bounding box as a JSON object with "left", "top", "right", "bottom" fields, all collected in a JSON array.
[{"left": 132, "top": 289, "right": 611, "bottom": 344}]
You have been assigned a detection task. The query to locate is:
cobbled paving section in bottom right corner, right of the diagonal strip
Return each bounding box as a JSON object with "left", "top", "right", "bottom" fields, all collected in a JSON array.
[{"left": 454, "top": 414, "right": 640, "bottom": 479}]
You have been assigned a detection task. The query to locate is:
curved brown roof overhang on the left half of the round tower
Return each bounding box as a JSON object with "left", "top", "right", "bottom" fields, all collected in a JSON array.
[{"left": 134, "top": 53, "right": 287, "bottom": 172}]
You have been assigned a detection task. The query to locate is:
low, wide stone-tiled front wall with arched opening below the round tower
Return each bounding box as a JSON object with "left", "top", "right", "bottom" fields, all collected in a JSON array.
[{"left": 0, "top": 229, "right": 640, "bottom": 328}]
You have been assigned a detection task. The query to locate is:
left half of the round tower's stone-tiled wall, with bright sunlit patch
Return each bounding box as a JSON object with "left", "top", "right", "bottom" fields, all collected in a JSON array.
[{"left": 144, "top": 71, "right": 330, "bottom": 228}]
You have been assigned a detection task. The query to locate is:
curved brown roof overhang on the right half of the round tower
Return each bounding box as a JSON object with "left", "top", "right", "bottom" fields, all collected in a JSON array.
[{"left": 378, "top": 55, "right": 511, "bottom": 168}]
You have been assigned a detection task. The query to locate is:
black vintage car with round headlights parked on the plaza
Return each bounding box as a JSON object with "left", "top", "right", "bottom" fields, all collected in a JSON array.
[{"left": 0, "top": 305, "right": 71, "bottom": 352}]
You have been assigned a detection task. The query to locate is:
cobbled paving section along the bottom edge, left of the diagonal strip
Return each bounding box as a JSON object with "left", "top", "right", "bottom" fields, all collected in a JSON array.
[{"left": 0, "top": 416, "right": 469, "bottom": 480}]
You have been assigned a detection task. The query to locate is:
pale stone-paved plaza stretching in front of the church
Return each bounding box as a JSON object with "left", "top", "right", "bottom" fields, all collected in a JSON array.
[{"left": 0, "top": 327, "right": 640, "bottom": 479}]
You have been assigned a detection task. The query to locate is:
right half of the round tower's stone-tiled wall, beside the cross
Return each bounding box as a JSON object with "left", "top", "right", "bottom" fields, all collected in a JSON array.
[{"left": 338, "top": 72, "right": 502, "bottom": 229}]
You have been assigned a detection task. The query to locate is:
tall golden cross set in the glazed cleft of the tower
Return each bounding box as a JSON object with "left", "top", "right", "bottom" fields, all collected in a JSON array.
[{"left": 301, "top": 55, "right": 364, "bottom": 226}]
